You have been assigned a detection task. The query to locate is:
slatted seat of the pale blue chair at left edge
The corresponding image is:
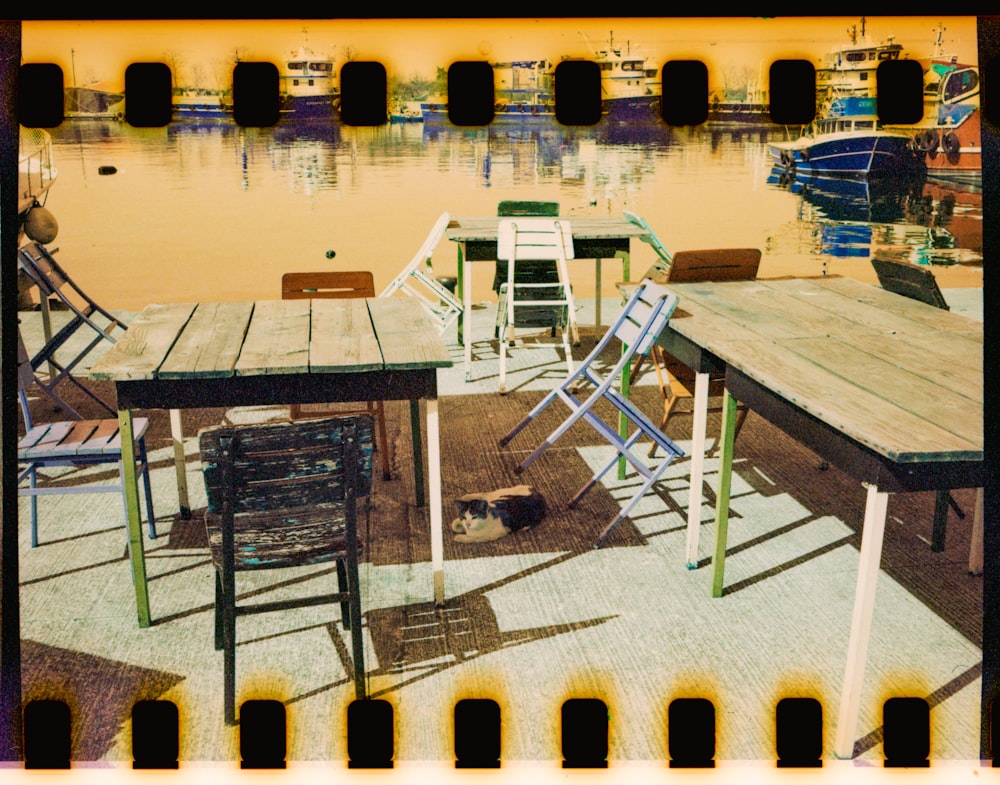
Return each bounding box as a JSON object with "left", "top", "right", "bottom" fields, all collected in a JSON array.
[{"left": 17, "top": 417, "right": 149, "bottom": 463}]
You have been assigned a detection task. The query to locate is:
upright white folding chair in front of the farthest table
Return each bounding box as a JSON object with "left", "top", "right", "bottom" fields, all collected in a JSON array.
[{"left": 497, "top": 218, "right": 575, "bottom": 393}]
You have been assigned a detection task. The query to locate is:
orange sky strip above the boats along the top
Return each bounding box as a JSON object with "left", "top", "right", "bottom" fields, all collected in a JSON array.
[{"left": 22, "top": 16, "right": 977, "bottom": 86}]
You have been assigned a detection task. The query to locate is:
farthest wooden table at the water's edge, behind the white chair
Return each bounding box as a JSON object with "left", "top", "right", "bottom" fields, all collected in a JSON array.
[{"left": 447, "top": 215, "right": 647, "bottom": 381}]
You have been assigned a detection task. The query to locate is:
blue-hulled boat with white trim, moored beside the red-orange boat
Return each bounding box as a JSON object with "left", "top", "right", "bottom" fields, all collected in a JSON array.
[{"left": 767, "top": 96, "right": 920, "bottom": 177}]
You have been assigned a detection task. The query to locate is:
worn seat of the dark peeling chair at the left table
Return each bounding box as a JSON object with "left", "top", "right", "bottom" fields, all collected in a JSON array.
[{"left": 205, "top": 502, "right": 360, "bottom": 570}]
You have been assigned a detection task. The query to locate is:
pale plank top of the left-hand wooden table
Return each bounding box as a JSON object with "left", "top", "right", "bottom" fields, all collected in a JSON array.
[{"left": 91, "top": 297, "right": 453, "bottom": 382}]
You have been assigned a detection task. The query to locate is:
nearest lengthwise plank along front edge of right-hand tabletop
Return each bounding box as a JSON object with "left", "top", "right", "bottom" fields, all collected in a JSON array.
[{"left": 712, "top": 337, "right": 983, "bottom": 462}]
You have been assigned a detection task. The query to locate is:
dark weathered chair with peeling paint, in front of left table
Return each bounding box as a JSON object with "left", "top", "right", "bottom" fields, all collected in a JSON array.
[{"left": 198, "top": 414, "right": 374, "bottom": 725}]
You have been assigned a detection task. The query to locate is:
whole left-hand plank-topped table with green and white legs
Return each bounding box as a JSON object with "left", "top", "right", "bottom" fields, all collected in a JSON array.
[{"left": 91, "top": 297, "right": 453, "bottom": 627}]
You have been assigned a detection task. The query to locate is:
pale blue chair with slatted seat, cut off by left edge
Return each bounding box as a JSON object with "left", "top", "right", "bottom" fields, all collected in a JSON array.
[{"left": 17, "top": 330, "right": 156, "bottom": 548}]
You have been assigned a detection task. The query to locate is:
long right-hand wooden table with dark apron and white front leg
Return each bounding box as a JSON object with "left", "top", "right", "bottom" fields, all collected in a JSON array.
[{"left": 660, "top": 278, "right": 985, "bottom": 758}]
